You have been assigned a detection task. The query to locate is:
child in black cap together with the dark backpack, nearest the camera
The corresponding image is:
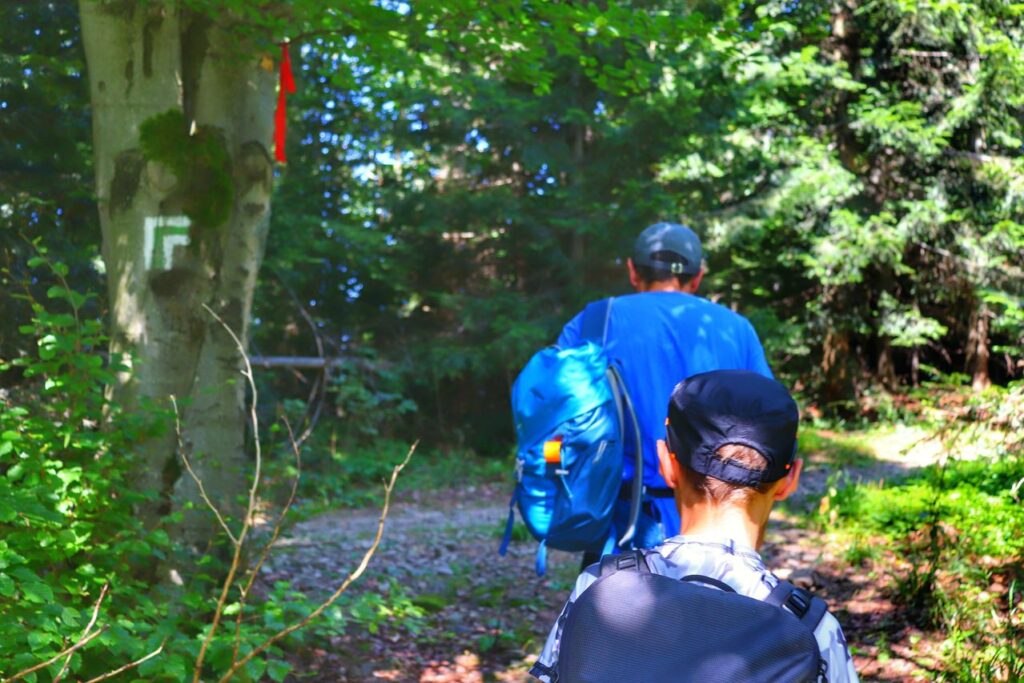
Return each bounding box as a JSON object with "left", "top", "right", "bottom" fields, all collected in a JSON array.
[{"left": 530, "top": 371, "right": 858, "bottom": 683}]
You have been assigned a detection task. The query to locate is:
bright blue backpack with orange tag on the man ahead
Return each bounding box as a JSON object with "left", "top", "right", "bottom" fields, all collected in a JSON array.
[{"left": 498, "top": 299, "right": 642, "bottom": 575}]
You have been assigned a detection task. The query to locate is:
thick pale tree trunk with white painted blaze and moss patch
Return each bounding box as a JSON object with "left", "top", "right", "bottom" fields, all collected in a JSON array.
[{"left": 80, "top": 0, "right": 274, "bottom": 546}]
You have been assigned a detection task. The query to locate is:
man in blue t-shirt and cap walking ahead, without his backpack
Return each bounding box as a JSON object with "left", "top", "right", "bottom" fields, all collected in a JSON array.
[{"left": 558, "top": 223, "right": 772, "bottom": 552}]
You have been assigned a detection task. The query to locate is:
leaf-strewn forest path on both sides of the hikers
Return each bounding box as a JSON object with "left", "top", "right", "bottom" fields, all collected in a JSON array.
[{"left": 261, "top": 429, "right": 942, "bottom": 683}]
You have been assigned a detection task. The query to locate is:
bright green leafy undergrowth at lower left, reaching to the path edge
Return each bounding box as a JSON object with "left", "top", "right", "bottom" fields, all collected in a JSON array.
[{"left": 0, "top": 258, "right": 422, "bottom": 683}]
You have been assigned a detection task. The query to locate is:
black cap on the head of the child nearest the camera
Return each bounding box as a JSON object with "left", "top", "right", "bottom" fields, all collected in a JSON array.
[{"left": 666, "top": 370, "right": 800, "bottom": 486}]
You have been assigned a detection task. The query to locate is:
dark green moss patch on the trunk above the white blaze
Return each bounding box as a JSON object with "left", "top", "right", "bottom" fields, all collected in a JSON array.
[{"left": 139, "top": 110, "right": 234, "bottom": 230}]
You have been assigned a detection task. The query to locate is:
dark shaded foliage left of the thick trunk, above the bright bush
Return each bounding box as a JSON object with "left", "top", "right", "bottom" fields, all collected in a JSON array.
[{"left": 0, "top": 2, "right": 101, "bottom": 366}]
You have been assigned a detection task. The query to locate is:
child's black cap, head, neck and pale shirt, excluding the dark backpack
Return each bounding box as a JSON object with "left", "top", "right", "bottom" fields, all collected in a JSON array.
[{"left": 530, "top": 371, "right": 857, "bottom": 683}]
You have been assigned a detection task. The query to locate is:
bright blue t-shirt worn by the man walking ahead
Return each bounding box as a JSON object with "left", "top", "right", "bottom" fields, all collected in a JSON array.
[{"left": 558, "top": 292, "right": 772, "bottom": 488}]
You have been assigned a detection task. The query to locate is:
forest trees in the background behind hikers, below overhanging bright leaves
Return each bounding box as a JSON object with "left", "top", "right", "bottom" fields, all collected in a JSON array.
[{"left": 0, "top": 2, "right": 1024, "bottom": 453}]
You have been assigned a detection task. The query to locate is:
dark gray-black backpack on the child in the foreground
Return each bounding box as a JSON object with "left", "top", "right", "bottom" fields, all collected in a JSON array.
[{"left": 550, "top": 551, "right": 827, "bottom": 683}]
